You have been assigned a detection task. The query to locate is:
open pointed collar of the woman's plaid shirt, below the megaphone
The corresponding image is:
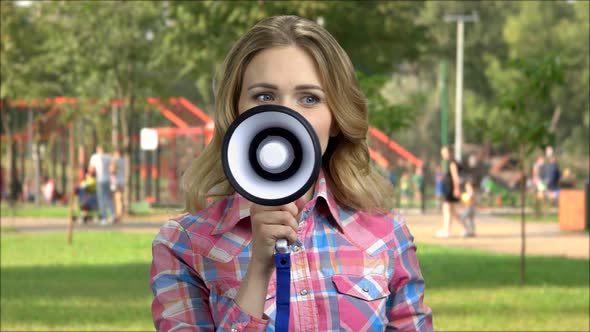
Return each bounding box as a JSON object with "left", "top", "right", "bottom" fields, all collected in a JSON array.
[{"left": 211, "top": 169, "right": 350, "bottom": 235}]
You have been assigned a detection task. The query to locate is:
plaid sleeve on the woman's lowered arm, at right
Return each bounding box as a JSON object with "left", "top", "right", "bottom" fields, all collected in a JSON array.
[{"left": 387, "top": 216, "right": 434, "bottom": 332}]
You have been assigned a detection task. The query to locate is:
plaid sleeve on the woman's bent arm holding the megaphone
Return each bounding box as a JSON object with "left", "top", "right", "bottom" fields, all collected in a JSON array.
[{"left": 150, "top": 220, "right": 269, "bottom": 332}]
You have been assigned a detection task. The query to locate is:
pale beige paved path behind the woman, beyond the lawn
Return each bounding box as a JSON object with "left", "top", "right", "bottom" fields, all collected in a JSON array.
[{"left": 0, "top": 211, "right": 590, "bottom": 259}]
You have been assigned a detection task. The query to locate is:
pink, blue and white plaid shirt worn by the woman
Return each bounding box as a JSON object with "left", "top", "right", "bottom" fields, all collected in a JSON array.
[{"left": 150, "top": 173, "right": 433, "bottom": 331}]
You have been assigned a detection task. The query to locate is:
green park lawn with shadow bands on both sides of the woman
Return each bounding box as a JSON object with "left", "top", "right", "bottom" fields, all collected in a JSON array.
[{"left": 0, "top": 232, "right": 590, "bottom": 331}]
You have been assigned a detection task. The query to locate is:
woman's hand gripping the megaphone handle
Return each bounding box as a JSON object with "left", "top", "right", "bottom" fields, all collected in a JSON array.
[{"left": 250, "top": 203, "right": 299, "bottom": 271}]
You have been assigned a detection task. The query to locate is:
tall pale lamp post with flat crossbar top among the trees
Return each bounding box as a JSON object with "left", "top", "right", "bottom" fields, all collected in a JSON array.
[{"left": 444, "top": 12, "right": 479, "bottom": 162}]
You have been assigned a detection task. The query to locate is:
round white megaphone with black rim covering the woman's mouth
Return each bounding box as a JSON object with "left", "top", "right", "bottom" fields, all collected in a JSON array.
[{"left": 221, "top": 105, "right": 321, "bottom": 206}]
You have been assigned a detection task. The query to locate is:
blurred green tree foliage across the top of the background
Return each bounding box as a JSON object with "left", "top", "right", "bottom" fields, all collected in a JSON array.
[{"left": 0, "top": 0, "right": 590, "bottom": 166}]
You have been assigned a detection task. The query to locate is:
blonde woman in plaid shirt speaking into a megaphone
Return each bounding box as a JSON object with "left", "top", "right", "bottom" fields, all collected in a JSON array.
[{"left": 150, "top": 16, "right": 432, "bottom": 331}]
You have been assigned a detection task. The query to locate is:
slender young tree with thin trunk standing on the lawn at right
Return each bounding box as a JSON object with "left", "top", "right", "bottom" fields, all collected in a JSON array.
[{"left": 486, "top": 55, "right": 564, "bottom": 282}]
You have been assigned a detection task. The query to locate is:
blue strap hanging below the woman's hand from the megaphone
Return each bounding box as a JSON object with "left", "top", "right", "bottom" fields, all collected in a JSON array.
[{"left": 275, "top": 252, "right": 291, "bottom": 332}]
